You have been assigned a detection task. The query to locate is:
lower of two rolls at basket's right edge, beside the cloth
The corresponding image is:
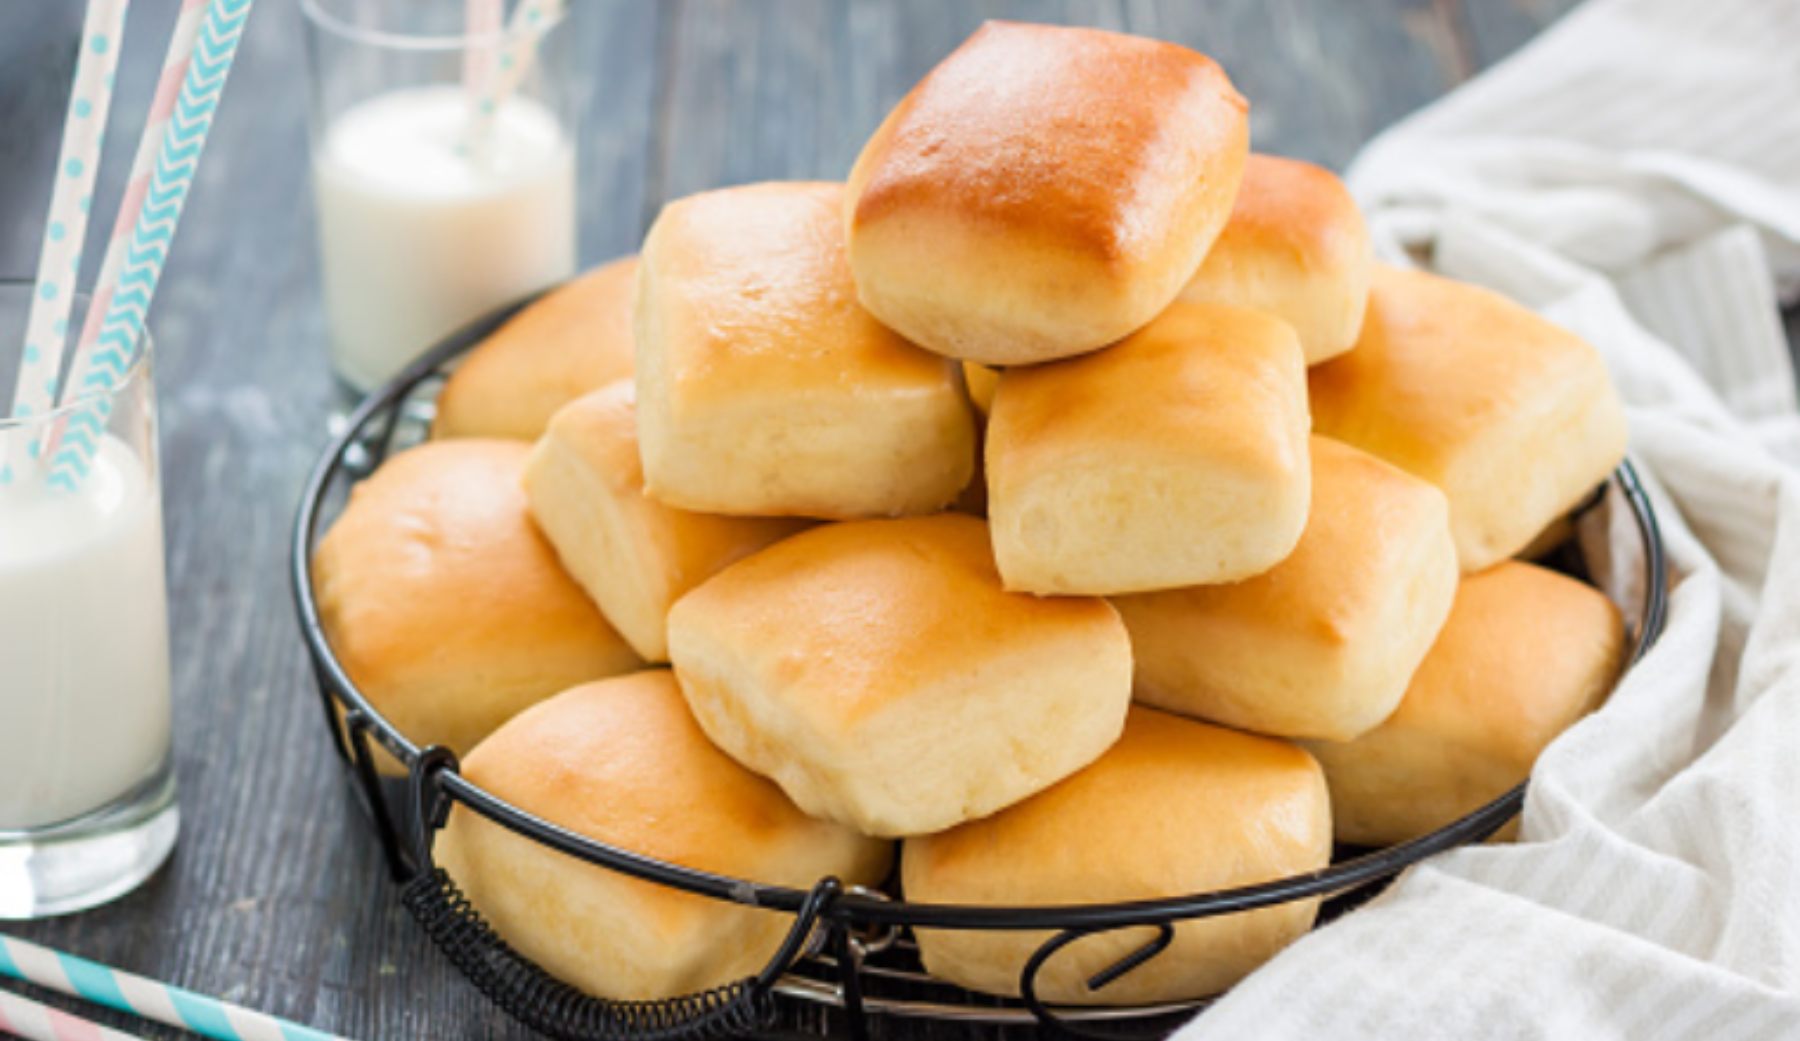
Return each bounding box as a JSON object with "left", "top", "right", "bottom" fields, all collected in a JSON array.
[{"left": 1309, "top": 560, "right": 1625, "bottom": 845}]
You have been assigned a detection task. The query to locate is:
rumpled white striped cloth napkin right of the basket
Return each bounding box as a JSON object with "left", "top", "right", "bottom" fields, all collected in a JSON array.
[{"left": 1183, "top": 0, "right": 1800, "bottom": 1041}]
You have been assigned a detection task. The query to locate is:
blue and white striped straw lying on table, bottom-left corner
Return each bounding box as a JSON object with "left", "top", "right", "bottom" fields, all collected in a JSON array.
[{"left": 0, "top": 935, "right": 344, "bottom": 1041}]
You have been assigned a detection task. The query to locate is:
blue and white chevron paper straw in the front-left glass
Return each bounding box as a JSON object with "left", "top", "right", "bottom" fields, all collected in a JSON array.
[{"left": 50, "top": 0, "right": 256, "bottom": 490}]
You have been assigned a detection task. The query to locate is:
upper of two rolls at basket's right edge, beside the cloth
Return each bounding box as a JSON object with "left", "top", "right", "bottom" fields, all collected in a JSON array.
[{"left": 1310, "top": 267, "right": 1625, "bottom": 571}]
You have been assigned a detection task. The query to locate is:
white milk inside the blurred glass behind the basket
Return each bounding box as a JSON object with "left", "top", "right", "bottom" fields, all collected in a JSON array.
[{"left": 313, "top": 85, "right": 576, "bottom": 389}]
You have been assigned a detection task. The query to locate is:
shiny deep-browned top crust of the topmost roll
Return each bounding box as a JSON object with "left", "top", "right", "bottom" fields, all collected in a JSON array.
[{"left": 851, "top": 22, "right": 1249, "bottom": 258}]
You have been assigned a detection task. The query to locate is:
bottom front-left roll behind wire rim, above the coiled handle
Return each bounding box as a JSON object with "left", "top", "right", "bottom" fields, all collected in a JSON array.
[{"left": 437, "top": 670, "right": 889, "bottom": 1000}]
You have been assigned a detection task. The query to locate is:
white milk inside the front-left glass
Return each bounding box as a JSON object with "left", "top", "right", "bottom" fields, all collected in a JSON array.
[{"left": 0, "top": 438, "right": 169, "bottom": 830}]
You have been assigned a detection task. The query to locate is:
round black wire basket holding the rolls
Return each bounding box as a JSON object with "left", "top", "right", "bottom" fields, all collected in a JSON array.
[{"left": 290, "top": 291, "right": 1667, "bottom": 1041}]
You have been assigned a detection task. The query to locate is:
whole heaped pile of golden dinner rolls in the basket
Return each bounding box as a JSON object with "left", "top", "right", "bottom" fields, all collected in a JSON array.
[{"left": 313, "top": 23, "right": 1625, "bottom": 1003}]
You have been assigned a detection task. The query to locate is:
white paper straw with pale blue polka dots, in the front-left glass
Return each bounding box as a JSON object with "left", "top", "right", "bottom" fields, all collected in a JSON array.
[{"left": 13, "top": 0, "right": 128, "bottom": 425}]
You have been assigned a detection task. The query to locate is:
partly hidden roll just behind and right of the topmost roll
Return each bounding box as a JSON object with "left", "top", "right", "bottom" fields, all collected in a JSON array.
[{"left": 1181, "top": 155, "right": 1375, "bottom": 366}]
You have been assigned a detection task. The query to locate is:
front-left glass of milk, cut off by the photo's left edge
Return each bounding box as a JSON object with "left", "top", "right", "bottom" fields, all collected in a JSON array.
[{"left": 0, "top": 281, "right": 180, "bottom": 919}]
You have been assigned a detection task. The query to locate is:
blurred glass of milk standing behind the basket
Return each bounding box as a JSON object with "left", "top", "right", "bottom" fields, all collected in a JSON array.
[{"left": 301, "top": 0, "right": 578, "bottom": 391}]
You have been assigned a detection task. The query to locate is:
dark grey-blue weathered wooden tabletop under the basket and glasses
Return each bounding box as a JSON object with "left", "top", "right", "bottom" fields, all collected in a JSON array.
[{"left": 0, "top": 0, "right": 1571, "bottom": 1041}]
